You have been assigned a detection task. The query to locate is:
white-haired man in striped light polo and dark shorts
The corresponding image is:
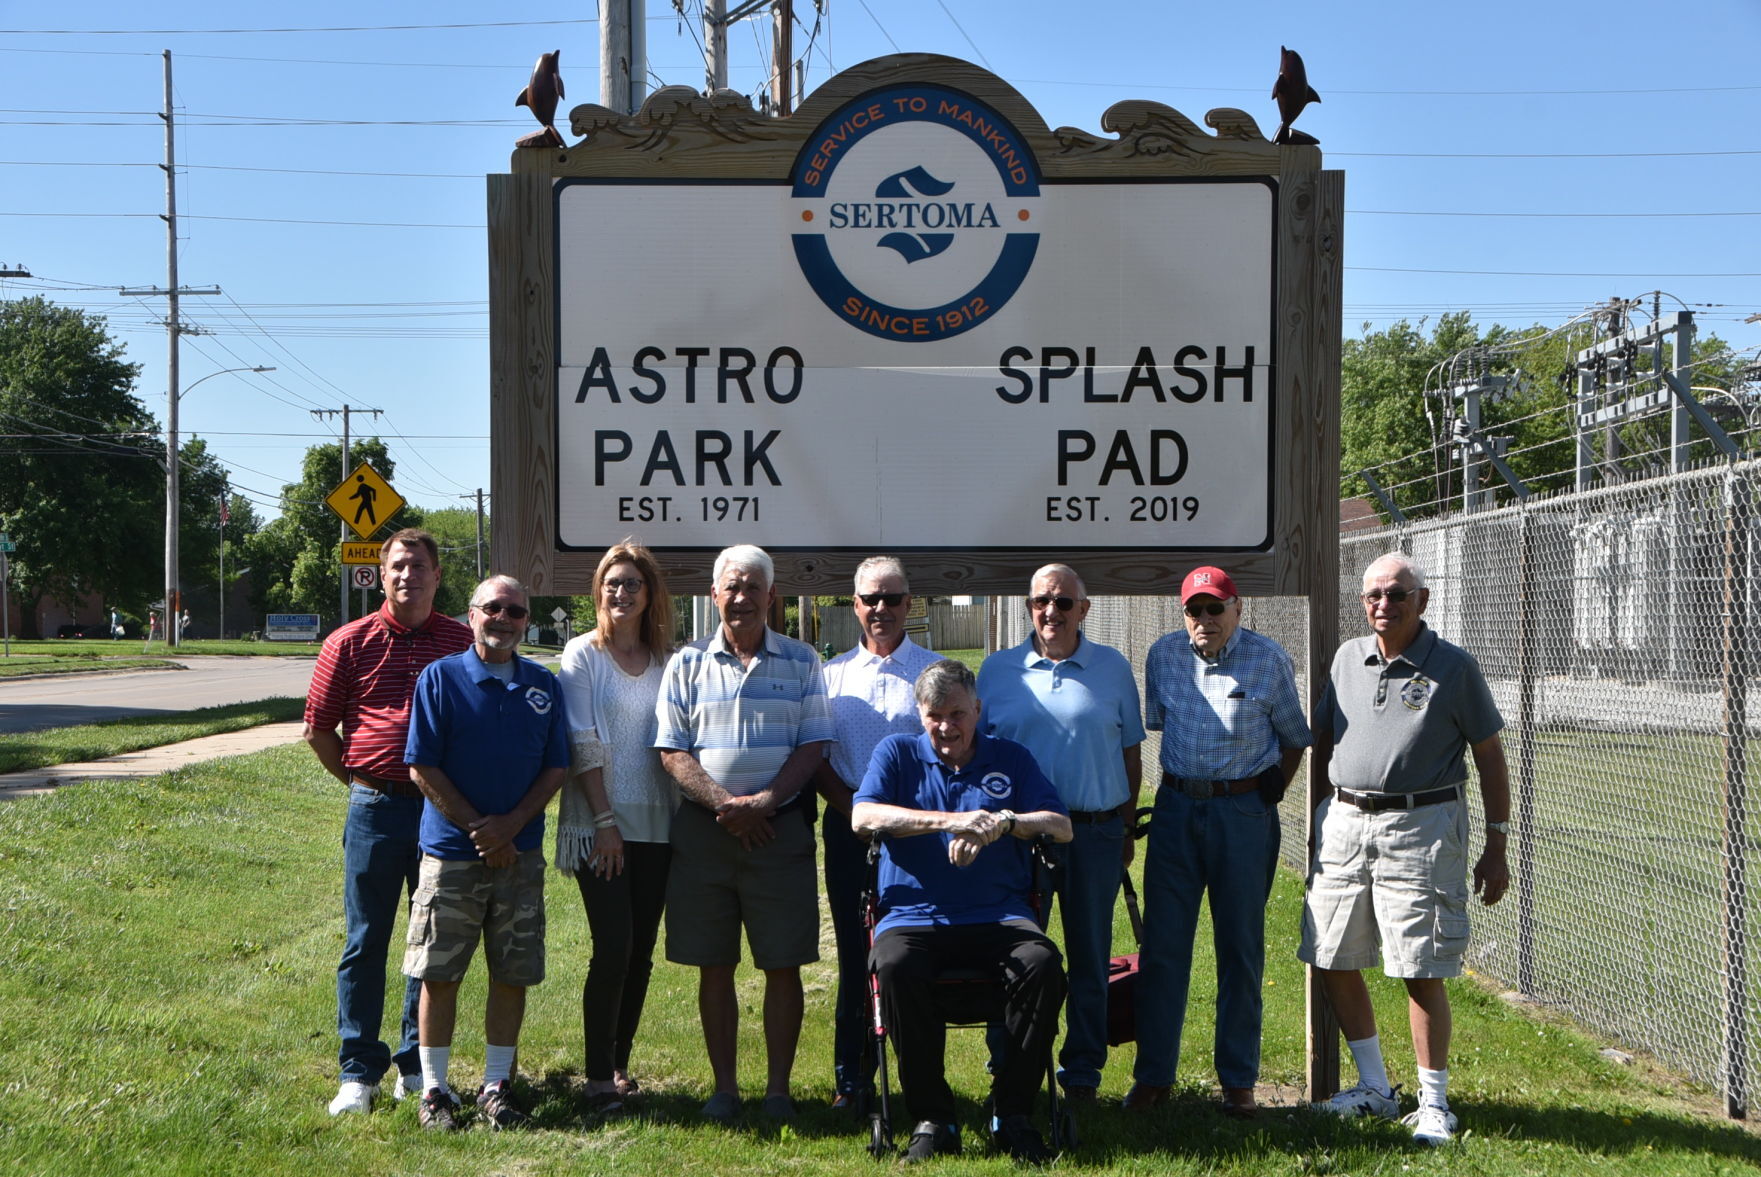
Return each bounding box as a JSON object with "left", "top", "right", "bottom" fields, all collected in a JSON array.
[{"left": 655, "top": 544, "right": 835, "bottom": 1121}]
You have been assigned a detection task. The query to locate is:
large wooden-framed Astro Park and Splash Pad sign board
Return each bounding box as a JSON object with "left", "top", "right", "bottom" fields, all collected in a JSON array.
[{"left": 490, "top": 55, "right": 1344, "bottom": 594}]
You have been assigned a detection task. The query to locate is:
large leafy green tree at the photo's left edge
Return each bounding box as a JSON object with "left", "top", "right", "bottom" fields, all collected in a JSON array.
[{"left": 0, "top": 298, "right": 166, "bottom": 638}]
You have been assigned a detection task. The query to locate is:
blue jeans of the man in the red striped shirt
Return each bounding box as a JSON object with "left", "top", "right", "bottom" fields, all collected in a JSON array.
[{"left": 336, "top": 784, "right": 423, "bottom": 1084}]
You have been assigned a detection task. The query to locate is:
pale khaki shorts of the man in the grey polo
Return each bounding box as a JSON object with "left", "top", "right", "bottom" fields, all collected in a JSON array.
[{"left": 1296, "top": 796, "right": 1469, "bottom": 978}]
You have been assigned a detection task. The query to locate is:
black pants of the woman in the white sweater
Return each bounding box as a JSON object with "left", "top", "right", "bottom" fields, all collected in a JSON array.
[{"left": 574, "top": 842, "right": 673, "bottom": 1082}]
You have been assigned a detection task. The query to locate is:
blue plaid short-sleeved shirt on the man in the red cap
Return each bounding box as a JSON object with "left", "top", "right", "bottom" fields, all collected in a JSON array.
[{"left": 1143, "top": 629, "right": 1314, "bottom": 781}]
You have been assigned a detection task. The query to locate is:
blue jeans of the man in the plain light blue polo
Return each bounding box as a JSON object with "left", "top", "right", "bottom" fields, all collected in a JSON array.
[{"left": 1058, "top": 818, "right": 1125, "bottom": 1087}]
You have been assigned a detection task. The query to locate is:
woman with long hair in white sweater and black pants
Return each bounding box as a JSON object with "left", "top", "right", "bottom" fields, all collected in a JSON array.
[{"left": 556, "top": 539, "right": 678, "bottom": 1112}]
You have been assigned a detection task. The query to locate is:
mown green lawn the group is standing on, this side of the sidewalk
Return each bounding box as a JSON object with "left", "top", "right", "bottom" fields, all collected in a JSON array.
[{"left": 0, "top": 745, "right": 1761, "bottom": 1177}]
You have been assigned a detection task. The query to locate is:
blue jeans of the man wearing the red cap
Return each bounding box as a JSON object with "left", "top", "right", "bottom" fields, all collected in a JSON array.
[{"left": 1134, "top": 786, "right": 1278, "bottom": 1087}]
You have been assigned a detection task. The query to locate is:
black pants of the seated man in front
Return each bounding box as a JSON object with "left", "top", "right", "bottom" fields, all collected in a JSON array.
[{"left": 868, "top": 920, "right": 1065, "bottom": 1124}]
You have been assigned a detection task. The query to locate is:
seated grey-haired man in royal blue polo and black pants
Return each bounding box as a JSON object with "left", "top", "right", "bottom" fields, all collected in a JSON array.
[{"left": 851, "top": 659, "right": 1071, "bottom": 1163}]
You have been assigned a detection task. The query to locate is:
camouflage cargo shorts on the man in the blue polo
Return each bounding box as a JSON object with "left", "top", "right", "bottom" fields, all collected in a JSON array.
[{"left": 403, "top": 849, "right": 544, "bottom": 985}]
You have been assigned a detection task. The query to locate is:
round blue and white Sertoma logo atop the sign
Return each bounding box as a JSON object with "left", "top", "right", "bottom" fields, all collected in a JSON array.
[{"left": 791, "top": 85, "right": 1039, "bottom": 342}]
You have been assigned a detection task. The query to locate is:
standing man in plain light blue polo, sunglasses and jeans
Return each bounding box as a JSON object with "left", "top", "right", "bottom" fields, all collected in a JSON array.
[{"left": 979, "top": 564, "right": 1143, "bottom": 1105}]
